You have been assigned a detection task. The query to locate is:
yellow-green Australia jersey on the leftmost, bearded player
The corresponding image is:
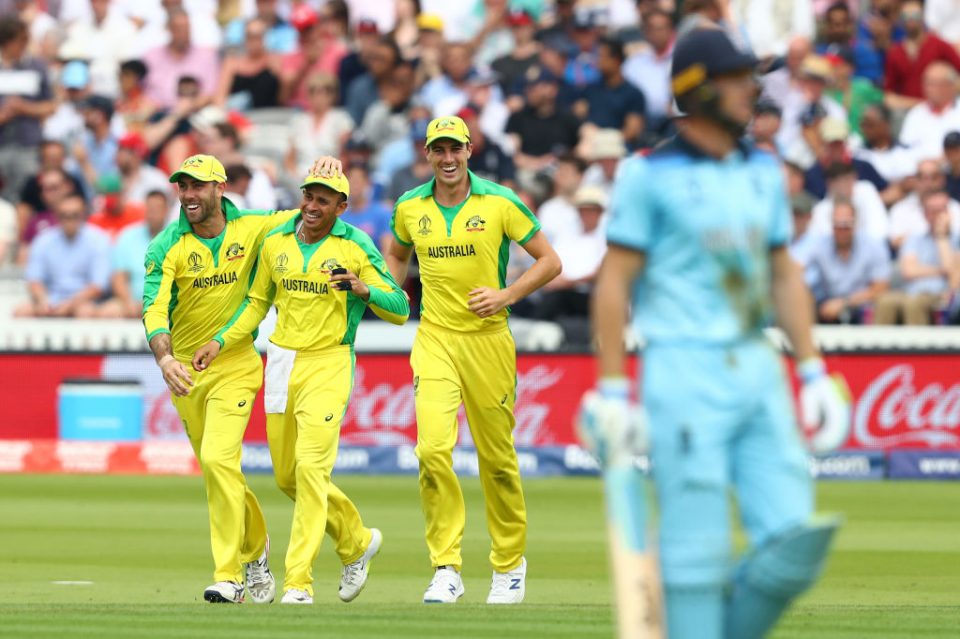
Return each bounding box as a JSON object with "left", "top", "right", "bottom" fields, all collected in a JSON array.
[{"left": 143, "top": 198, "right": 300, "bottom": 361}]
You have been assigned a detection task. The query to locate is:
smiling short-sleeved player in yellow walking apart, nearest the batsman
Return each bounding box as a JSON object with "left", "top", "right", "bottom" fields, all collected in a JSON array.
[{"left": 387, "top": 117, "right": 560, "bottom": 604}]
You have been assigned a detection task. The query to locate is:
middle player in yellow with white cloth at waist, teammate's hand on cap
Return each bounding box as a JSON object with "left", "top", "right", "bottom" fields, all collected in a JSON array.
[{"left": 193, "top": 170, "right": 410, "bottom": 604}]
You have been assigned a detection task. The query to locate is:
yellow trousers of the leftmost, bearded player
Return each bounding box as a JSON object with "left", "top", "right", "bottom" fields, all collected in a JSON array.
[{"left": 171, "top": 346, "right": 267, "bottom": 584}]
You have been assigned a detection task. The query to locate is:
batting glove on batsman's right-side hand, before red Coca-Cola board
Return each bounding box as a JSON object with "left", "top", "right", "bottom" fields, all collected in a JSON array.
[{"left": 797, "top": 357, "right": 851, "bottom": 453}]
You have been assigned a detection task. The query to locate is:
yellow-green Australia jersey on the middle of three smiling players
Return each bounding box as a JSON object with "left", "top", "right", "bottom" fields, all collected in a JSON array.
[{"left": 214, "top": 216, "right": 410, "bottom": 351}]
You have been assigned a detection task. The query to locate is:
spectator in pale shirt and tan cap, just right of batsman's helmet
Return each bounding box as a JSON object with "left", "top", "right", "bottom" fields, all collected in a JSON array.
[{"left": 777, "top": 55, "right": 847, "bottom": 165}]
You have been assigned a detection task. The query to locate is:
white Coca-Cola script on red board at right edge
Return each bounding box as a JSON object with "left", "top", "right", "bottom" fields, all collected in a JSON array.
[{"left": 853, "top": 364, "right": 960, "bottom": 448}]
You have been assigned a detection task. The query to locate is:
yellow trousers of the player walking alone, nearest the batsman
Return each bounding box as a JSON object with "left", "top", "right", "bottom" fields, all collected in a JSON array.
[{"left": 410, "top": 320, "right": 527, "bottom": 572}]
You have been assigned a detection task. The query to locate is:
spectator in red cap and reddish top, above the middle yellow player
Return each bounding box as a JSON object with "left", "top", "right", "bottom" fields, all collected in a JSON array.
[{"left": 280, "top": 4, "right": 348, "bottom": 109}]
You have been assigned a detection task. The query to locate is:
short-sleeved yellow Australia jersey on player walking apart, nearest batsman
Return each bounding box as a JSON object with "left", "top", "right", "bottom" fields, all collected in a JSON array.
[{"left": 390, "top": 172, "right": 540, "bottom": 331}]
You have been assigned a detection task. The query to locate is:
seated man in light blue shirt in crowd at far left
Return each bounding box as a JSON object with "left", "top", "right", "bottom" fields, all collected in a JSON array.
[{"left": 13, "top": 195, "right": 110, "bottom": 317}]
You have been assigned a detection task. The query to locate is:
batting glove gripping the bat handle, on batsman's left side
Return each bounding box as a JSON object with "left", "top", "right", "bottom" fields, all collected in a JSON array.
[{"left": 577, "top": 377, "right": 650, "bottom": 466}]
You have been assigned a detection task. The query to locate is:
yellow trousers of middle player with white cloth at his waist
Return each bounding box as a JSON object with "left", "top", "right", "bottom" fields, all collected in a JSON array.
[{"left": 267, "top": 346, "right": 372, "bottom": 595}]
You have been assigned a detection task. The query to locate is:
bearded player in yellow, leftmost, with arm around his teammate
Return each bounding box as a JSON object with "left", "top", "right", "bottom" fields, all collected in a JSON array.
[{"left": 143, "top": 155, "right": 340, "bottom": 603}]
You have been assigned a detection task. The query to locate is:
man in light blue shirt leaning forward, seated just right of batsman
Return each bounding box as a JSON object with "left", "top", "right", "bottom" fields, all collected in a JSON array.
[{"left": 806, "top": 200, "right": 890, "bottom": 324}]
